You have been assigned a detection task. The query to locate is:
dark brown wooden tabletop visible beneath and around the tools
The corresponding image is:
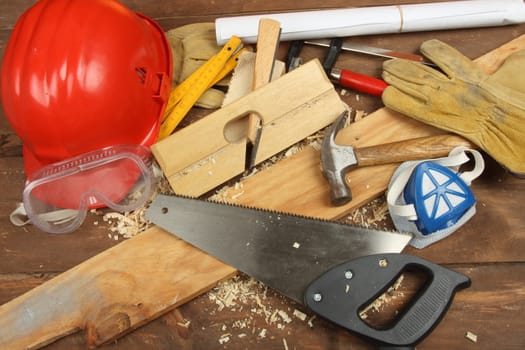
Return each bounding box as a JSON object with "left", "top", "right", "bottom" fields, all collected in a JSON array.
[{"left": 0, "top": 0, "right": 525, "bottom": 349}]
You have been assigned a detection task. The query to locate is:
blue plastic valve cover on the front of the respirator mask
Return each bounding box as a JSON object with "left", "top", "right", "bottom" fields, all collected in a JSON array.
[{"left": 403, "top": 161, "right": 476, "bottom": 235}]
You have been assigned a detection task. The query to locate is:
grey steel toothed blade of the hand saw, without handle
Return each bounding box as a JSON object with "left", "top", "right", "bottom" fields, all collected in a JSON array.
[{"left": 146, "top": 195, "right": 411, "bottom": 303}]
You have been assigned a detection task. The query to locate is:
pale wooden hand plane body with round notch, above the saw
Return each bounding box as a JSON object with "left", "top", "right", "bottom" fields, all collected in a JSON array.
[{"left": 152, "top": 60, "right": 344, "bottom": 196}]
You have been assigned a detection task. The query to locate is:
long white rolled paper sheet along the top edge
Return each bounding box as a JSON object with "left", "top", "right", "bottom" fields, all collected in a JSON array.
[{"left": 215, "top": 0, "right": 525, "bottom": 45}]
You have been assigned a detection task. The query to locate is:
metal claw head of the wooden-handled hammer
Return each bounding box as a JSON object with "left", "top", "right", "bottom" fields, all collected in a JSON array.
[{"left": 321, "top": 110, "right": 357, "bottom": 206}]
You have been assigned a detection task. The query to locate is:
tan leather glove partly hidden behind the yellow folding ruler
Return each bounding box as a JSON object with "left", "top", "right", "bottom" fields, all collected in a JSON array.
[{"left": 166, "top": 23, "right": 227, "bottom": 109}]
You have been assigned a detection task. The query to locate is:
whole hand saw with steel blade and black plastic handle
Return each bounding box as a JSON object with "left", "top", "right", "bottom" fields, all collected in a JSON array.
[{"left": 146, "top": 195, "right": 470, "bottom": 349}]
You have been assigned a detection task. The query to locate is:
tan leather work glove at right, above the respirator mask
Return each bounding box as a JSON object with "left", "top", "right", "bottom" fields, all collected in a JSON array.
[{"left": 382, "top": 40, "right": 525, "bottom": 176}]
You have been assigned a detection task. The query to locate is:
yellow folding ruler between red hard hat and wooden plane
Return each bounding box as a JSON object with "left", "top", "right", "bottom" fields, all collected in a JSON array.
[{"left": 159, "top": 36, "right": 245, "bottom": 140}]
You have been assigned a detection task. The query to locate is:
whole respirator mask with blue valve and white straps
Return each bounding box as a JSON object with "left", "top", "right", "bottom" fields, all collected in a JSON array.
[{"left": 387, "top": 147, "right": 484, "bottom": 248}]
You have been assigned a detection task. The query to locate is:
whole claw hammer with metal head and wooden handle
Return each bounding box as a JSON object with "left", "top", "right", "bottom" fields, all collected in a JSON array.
[{"left": 321, "top": 111, "right": 475, "bottom": 206}]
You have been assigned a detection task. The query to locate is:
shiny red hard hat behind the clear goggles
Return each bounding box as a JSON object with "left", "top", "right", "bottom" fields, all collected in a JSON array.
[{"left": 1, "top": 0, "right": 172, "bottom": 178}]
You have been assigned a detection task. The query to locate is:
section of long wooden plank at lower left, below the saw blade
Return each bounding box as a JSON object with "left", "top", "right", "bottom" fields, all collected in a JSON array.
[{"left": 0, "top": 228, "right": 235, "bottom": 349}]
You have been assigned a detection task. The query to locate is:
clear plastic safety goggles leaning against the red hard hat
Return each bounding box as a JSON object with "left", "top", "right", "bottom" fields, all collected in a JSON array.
[{"left": 23, "top": 145, "right": 155, "bottom": 233}]
